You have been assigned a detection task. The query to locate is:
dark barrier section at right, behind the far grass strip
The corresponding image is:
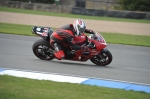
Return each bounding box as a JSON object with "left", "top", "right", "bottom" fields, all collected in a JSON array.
[{"left": 72, "top": 7, "right": 150, "bottom": 19}]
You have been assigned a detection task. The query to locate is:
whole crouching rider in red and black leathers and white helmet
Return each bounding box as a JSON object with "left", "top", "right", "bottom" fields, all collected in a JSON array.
[{"left": 50, "top": 19, "right": 94, "bottom": 60}]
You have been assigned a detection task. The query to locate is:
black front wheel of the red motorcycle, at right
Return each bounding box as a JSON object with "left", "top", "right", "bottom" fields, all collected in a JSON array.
[{"left": 90, "top": 50, "right": 113, "bottom": 66}]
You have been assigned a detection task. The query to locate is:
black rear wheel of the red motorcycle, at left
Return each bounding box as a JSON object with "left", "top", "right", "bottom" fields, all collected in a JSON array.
[{"left": 32, "top": 39, "right": 54, "bottom": 60}]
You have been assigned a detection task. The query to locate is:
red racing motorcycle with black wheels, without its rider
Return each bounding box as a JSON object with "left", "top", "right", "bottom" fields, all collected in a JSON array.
[{"left": 32, "top": 26, "right": 112, "bottom": 66}]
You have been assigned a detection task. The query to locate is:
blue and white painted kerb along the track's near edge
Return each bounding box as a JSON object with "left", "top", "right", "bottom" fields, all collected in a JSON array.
[{"left": 0, "top": 68, "right": 150, "bottom": 93}]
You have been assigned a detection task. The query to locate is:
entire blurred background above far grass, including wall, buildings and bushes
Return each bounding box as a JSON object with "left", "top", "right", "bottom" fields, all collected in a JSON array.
[{"left": 0, "top": 0, "right": 150, "bottom": 19}]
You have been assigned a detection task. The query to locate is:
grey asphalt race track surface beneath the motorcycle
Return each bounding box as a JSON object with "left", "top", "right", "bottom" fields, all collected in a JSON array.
[{"left": 0, "top": 33, "right": 150, "bottom": 84}]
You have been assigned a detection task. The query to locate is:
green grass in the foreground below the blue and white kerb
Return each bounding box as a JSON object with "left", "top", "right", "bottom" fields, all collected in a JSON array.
[{"left": 0, "top": 75, "right": 150, "bottom": 99}]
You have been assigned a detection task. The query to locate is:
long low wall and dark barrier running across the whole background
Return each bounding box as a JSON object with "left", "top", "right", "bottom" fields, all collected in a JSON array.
[{"left": 0, "top": 0, "right": 150, "bottom": 19}]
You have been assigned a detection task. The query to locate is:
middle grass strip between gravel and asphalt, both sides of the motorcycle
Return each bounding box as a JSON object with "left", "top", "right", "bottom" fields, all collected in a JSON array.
[{"left": 0, "top": 23, "right": 150, "bottom": 46}]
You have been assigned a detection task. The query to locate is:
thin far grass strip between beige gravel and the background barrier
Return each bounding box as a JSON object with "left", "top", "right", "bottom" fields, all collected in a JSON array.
[{"left": 0, "top": 6, "right": 150, "bottom": 24}]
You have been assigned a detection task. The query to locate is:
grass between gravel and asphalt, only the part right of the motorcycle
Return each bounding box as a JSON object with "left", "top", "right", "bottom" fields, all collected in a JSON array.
[{"left": 101, "top": 33, "right": 150, "bottom": 47}]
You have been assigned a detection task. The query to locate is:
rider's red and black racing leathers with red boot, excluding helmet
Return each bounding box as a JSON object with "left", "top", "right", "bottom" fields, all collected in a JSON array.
[{"left": 50, "top": 24, "right": 93, "bottom": 60}]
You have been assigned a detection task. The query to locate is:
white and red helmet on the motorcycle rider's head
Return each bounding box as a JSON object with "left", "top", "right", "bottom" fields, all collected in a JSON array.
[{"left": 73, "top": 19, "right": 86, "bottom": 36}]
